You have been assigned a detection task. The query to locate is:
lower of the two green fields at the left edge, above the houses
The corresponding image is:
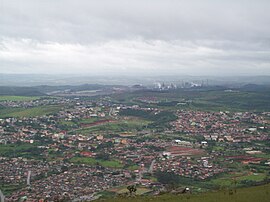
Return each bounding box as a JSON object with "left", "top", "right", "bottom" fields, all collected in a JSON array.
[{"left": 0, "top": 105, "right": 61, "bottom": 118}]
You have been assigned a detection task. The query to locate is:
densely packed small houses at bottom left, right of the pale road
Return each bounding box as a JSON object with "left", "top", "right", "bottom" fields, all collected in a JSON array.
[{"left": 6, "top": 166, "right": 130, "bottom": 201}]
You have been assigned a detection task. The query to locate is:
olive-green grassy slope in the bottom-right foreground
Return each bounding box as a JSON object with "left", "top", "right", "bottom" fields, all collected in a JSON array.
[{"left": 97, "top": 184, "right": 270, "bottom": 202}]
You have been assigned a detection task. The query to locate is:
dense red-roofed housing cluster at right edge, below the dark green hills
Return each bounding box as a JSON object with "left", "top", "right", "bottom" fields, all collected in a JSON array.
[{"left": 172, "top": 110, "right": 270, "bottom": 142}]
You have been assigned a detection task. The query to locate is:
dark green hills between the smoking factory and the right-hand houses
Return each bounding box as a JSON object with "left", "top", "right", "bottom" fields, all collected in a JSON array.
[{"left": 115, "top": 87, "right": 270, "bottom": 111}]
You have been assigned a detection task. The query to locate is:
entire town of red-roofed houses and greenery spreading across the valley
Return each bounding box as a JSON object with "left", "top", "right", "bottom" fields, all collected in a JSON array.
[{"left": 0, "top": 96, "right": 270, "bottom": 201}]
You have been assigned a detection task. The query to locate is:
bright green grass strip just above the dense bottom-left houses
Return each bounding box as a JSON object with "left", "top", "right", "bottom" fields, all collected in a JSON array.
[{"left": 69, "top": 157, "right": 123, "bottom": 168}]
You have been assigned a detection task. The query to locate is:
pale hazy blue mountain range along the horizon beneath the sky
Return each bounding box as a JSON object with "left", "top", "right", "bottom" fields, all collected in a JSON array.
[{"left": 0, "top": 74, "right": 270, "bottom": 86}]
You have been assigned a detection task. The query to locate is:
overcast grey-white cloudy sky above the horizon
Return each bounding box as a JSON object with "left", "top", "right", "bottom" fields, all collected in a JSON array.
[{"left": 0, "top": 0, "right": 270, "bottom": 76}]
